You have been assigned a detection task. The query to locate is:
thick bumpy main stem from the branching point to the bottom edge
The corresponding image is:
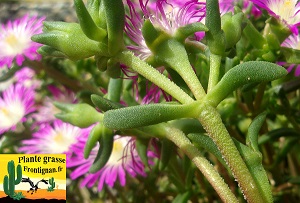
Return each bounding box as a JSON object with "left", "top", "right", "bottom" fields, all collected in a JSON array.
[{"left": 199, "top": 103, "right": 265, "bottom": 203}]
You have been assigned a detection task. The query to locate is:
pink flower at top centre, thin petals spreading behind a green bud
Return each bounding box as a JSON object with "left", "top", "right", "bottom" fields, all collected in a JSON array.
[{"left": 125, "top": 0, "right": 205, "bottom": 60}]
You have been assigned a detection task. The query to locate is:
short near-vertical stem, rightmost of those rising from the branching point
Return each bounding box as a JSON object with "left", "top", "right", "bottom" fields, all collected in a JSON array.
[{"left": 207, "top": 53, "right": 222, "bottom": 92}]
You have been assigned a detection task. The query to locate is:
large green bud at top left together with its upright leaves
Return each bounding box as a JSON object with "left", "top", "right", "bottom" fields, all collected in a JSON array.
[{"left": 32, "top": 0, "right": 125, "bottom": 60}]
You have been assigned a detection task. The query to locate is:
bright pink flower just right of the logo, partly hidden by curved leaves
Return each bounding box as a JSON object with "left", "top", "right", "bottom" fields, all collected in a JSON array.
[{"left": 67, "top": 133, "right": 153, "bottom": 191}]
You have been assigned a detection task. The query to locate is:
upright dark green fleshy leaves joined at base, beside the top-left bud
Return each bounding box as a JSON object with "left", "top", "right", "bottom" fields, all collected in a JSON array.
[{"left": 74, "top": 0, "right": 125, "bottom": 55}]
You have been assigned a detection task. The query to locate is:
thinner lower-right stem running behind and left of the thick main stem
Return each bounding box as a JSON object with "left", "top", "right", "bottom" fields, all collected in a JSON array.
[{"left": 165, "top": 126, "right": 238, "bottom": 202}]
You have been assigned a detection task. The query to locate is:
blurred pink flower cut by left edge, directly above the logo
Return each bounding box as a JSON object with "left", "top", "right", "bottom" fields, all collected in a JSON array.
[{"left": 0, "top": 84, "right": 35, "bottom": 134}]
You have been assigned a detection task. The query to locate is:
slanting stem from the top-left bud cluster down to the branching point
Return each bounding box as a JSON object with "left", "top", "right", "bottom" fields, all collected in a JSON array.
[{"left": 115, "top": 51, "right": 194, "bottom": 103}]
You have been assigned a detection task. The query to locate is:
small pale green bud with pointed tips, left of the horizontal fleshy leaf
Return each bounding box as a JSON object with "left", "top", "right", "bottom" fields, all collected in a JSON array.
[{"left": 54, "top": 102, "right": 103, "bottom": 128}]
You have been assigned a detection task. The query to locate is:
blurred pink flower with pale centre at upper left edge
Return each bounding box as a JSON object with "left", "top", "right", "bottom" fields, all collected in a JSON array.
[{"left": 0, "top": 15, "right": 45, "bottom": 68}]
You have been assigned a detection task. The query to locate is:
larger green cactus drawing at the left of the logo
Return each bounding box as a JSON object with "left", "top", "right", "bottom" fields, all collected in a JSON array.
[{"left": 3, "top": 160, "right": 22, "bottom": 198}]
